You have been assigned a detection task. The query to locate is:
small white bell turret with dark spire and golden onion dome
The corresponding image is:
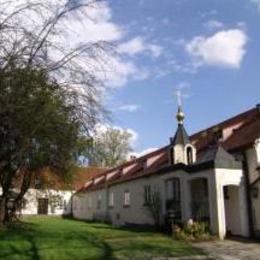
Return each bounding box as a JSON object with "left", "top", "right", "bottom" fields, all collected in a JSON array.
[{"left": 169, "top": 106, "right": 196, "bottom": 164}]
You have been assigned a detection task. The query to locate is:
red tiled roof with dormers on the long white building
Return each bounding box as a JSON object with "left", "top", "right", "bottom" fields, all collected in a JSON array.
[{"left": 77, "top": 107, "right": 260, "bottom": 191}]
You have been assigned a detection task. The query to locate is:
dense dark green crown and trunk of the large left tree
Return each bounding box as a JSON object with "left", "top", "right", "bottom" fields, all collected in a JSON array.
[{"left": 0, "top": 66, "right": 93, "bottom": 222}]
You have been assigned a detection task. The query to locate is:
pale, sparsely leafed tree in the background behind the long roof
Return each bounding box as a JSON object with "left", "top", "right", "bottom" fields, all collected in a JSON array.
[{"left": 88, "top": 127, "right": 132, "bottom": 167}]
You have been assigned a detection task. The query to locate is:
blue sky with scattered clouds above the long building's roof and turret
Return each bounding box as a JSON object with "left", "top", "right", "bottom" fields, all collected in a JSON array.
[{"left": 89, "top": 0, "right": 260, "bottom": 152}]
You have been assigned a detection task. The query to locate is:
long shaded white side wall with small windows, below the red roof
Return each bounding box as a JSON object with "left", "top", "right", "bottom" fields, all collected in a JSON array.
[{"left": 73, "top": 170, "right": 214, "bottom": 228}]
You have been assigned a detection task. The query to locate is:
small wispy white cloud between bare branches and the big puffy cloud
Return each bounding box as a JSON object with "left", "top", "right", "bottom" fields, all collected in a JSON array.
[{"left": 118, "top": 37, "right": 162, "bottom": 57}]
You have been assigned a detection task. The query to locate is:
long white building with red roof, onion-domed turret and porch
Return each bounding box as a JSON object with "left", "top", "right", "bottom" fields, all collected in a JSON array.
[{"left": 73, "top": 106, "right": 260, "bottom": 238}]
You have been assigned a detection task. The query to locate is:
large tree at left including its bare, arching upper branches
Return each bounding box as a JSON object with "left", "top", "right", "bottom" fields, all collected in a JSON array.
[{"left": 0, "top": 0, "right": 111, "bottom": 225}]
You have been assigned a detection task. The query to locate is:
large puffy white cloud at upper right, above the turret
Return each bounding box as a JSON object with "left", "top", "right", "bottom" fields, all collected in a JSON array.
[{"left": 185, "top": 29, "right": 248, "bottom": 68}]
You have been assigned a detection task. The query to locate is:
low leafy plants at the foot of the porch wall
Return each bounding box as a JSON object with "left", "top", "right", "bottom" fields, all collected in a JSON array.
[{"left": 172, "top": 222, "right": 213, "bottom": 241}]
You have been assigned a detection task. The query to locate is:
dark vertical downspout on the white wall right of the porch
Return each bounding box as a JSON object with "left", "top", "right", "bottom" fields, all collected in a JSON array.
[{"left": 242, "top": 151, "right": 255, "bottom": 238}]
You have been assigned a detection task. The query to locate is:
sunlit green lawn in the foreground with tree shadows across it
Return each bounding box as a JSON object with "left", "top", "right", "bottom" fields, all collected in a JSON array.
[{"left": 0, "top": 217, "right": 201, "bottom": 260}]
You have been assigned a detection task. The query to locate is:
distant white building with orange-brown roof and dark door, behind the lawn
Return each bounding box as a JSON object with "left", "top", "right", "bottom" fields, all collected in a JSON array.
[{"left": 0, "top": 167, "right": 101, "bottom": 216}]
